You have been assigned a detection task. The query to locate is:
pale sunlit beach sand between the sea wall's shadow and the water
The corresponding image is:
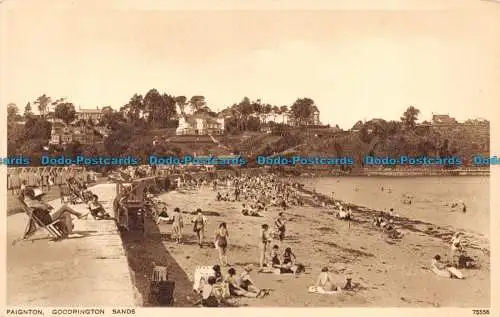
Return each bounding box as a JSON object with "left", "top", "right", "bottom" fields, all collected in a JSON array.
[{"left": 151, "top": 188, "right": 490, "bottom": 307}]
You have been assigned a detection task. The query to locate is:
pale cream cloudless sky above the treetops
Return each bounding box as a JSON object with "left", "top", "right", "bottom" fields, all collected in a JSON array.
[{"left": 0, "top": 0, "right": 500, "bottom": 128}]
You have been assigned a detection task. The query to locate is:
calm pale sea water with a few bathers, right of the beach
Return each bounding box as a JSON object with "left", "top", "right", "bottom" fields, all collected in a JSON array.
[{"left": 302, "top": 176, "right": 490, "bottom": 237}]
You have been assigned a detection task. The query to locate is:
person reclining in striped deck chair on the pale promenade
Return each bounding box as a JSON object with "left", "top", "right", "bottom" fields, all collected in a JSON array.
[{"left": 23, "top": 188, "right": 87, "bottom": 238}]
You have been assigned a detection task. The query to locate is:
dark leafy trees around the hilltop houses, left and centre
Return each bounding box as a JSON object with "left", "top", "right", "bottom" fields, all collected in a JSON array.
[{"left": 7, "top": 89, "right": 324, "bottom": 164}]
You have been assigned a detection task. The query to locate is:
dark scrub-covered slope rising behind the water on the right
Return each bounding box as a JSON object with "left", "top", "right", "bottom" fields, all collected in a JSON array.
[{"left": 219, "top": 125, "right": 489, "bottom": 165}]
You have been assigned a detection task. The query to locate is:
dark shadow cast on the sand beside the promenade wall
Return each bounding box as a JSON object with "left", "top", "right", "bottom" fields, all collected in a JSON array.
[{"left": 121, "top": 219, "right": 197, "bottom": 307}]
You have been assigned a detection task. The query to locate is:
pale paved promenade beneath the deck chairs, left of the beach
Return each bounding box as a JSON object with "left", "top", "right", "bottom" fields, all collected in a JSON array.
[{"left": 7, "top": 184, "right": 141, "bottom": 307}]
